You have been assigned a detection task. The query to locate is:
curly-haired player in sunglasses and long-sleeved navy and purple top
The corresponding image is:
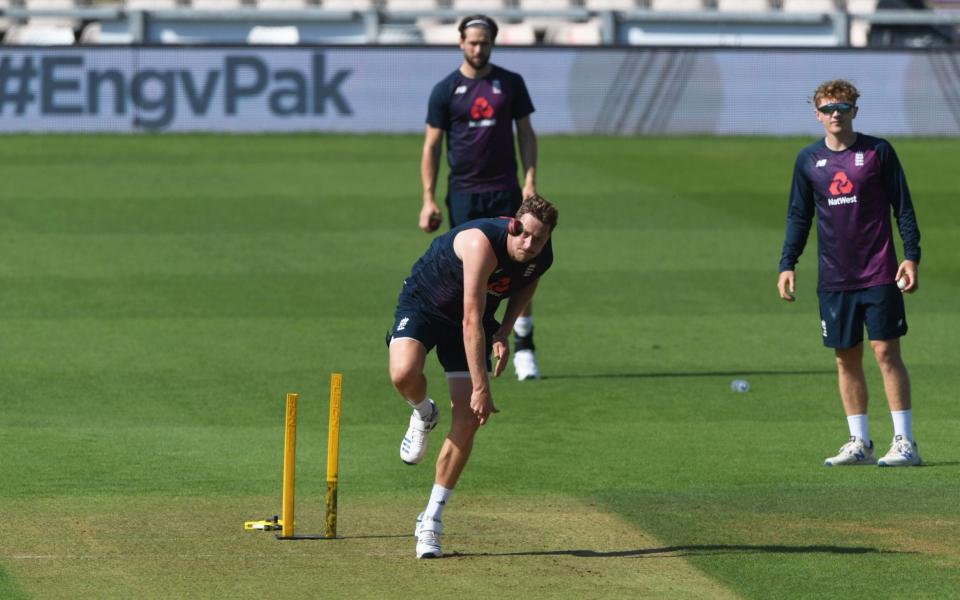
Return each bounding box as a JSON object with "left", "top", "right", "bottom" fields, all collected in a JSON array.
[{"left": 777, "top": 79, "right": 921, "bottom": 467}]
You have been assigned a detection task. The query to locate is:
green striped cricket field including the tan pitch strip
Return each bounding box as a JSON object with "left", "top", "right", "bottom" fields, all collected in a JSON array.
[{"left": 0, "top": 136, "right": 960, "bottom": 599}]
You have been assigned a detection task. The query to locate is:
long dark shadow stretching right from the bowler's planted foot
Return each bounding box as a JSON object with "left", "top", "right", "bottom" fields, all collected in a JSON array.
[{"left": 449, "top": 544, "right": 903, "bottom": 558}]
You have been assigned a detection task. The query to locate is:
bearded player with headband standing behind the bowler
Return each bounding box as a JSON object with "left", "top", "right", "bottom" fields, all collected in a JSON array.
[{"left": 419, "top": 15, "right": 540, "bottom": 381}]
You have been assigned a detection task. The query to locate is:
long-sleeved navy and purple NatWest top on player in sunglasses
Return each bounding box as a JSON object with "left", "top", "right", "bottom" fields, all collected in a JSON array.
[{"left": 780, "top": 133, "right": 920, "bottom": 291}]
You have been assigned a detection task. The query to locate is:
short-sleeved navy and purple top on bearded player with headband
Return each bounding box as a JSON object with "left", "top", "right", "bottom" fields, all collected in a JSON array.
[{"left": 427, "top": 65, "right": 534, "bottom": 193}]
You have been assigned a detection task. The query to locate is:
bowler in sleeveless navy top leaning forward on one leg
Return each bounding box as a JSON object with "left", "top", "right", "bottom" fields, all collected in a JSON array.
[{"left": 387, "top": 195, "right": 557, "bottom": 558}]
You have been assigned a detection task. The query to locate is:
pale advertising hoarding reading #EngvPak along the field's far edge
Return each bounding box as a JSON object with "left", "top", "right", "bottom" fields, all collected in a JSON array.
[{"left": 0, "top": 47, "right": 960, "bottom": 135}]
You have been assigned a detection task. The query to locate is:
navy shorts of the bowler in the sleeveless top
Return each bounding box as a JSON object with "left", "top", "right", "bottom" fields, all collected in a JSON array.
[{"left": 387, "top": 304, "right": 500, "bottom": 373}]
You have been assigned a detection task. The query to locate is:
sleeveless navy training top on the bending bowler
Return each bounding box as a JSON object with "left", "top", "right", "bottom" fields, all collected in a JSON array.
[{"left": 402, "top": 217, "right": 553, "bottom": 325}]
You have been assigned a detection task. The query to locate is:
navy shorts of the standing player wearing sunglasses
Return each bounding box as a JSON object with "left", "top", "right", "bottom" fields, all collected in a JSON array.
[{"left": 817, "top": 284, "right": 907, "bottom": 348}]
